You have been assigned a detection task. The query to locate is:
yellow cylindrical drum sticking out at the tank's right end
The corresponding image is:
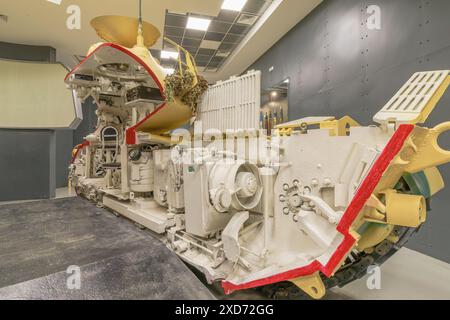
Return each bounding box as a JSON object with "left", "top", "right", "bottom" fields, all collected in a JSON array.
[{"left": 384, "top": 189, "right": 427, "bottom": 228}]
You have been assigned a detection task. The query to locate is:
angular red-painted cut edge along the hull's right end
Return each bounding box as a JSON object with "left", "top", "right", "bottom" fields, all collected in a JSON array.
[{"left": 222, "top": 125, "right": 414, "bottom": 294}]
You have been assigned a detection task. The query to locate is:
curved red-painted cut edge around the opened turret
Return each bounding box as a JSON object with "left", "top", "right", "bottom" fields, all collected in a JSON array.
[{"left": 64, "top": 43, "right": 171, "bottom": 145}]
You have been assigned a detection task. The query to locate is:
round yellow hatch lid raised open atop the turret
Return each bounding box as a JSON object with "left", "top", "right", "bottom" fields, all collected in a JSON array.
[{"left": 91, "top": 16, "right": 161, "bottom": 48}]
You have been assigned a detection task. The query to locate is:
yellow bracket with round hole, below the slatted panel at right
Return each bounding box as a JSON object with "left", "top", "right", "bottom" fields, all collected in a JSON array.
[{"left": 403, "top": 122, "right": 450, "bottom": 172}]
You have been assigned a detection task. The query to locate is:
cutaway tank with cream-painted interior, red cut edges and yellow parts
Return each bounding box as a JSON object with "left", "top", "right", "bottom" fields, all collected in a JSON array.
[{"left": 66, "top": 12, "right": 450, "bottom": 298}]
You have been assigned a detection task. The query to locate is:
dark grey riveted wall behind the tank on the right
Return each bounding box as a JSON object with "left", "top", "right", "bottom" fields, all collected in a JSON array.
[{"left": 250, "top": 0, "right": 450, "bottom": 262}]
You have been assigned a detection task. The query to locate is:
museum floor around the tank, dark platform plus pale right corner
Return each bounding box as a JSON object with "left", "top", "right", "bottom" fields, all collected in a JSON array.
[{"left": 0, "top": 189, "right": 450, "bottom": 300}]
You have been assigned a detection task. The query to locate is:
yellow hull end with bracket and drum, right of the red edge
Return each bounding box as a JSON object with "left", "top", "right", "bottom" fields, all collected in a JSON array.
[{"left": 352, "top": 123, "right": 450, "bottom": 252}]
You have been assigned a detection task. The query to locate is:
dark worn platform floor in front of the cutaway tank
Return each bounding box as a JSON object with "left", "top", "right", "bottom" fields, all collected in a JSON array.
[{"left": 0, "top": 198, "right": 214, "bottom": 300}]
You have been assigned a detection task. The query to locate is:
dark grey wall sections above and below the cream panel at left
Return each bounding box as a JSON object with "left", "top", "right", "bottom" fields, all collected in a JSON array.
[{"left": 0, "top": 42, "right": 96, "bottom": 201}]
